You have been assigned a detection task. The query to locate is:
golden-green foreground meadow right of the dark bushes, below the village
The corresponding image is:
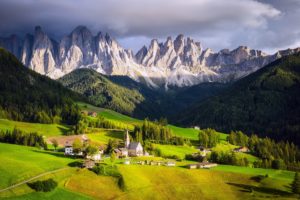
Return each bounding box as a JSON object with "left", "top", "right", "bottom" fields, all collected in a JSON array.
[{"left": 119, "top": 165, "right": 292, "bottom": 200}]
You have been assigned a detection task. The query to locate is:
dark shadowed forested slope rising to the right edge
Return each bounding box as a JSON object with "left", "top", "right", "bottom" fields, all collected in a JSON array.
[{"left": 177, "top": 53, "right": 300, "bottom": 144}]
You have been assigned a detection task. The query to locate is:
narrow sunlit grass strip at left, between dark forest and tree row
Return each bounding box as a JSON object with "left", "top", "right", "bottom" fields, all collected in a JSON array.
[{"left": 0, "top": 119, "right": 69, "bottom": 136}]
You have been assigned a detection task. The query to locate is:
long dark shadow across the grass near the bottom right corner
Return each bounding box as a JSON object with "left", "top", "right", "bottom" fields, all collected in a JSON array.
[{"left": 227, "top": 183, "right": 292, "bottom": 196}]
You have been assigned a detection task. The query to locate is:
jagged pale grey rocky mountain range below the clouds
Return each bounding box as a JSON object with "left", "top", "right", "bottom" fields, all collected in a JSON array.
[{"left": 0, "top": 26, "right": 300, "bottom": 88}]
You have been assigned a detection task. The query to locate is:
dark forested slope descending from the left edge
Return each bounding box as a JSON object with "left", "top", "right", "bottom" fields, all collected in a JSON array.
[{"left": 0, "top": 48, "right": 84, "bottom": 124}]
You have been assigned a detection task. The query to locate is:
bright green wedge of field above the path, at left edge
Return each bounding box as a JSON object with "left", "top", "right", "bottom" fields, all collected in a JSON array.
[{"left": 0, "top": 143, "right": 74, "bottom": 189}]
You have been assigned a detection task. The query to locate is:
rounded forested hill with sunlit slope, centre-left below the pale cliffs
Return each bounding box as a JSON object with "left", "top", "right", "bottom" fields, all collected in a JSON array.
[{"left": 58, "top": 69, "right": 160, "bottom": 118}]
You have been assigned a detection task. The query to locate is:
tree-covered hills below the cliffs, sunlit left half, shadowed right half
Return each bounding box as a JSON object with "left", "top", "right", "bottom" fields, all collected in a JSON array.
[{"left": 58, "top": 69, "right": 227, "bottom": 120}]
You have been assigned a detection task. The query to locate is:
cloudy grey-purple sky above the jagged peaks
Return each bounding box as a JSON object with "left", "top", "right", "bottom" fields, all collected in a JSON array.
[{"left": 0, "top": 0, "right": 300, "bottom": 52}]
